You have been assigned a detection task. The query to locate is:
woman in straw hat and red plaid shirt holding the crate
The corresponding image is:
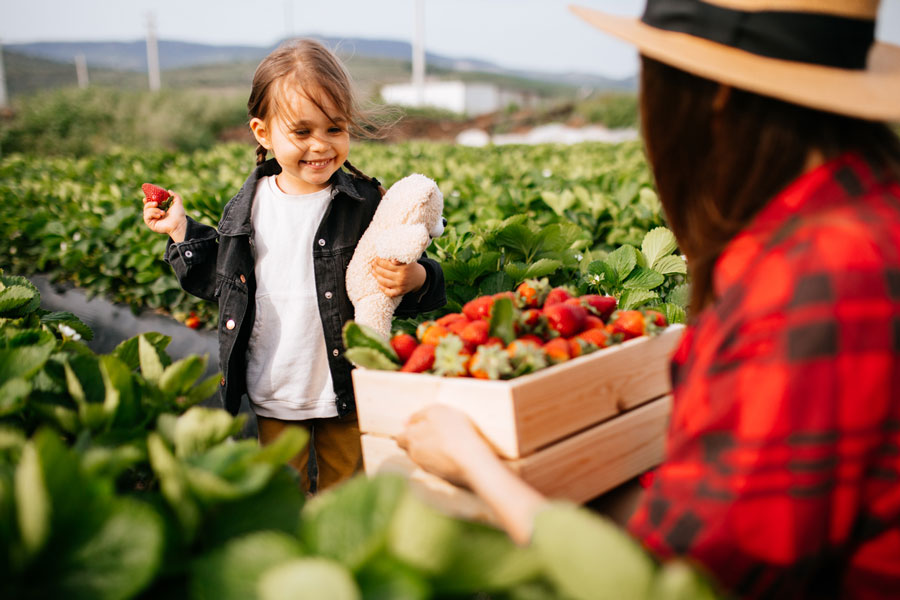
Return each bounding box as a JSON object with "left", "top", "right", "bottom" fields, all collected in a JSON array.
[{"left": 399, "top": 0, "right": 900, "bottom": 598}]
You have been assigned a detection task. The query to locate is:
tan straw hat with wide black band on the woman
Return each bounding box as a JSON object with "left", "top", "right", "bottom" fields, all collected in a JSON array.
[{"left": 569, "top": 0, "right": 900, "bottom": 121}]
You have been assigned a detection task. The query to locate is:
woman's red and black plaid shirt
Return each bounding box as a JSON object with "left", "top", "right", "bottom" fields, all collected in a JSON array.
[{"left": 630, "top": 155, "right": 900, "bottom": 599}]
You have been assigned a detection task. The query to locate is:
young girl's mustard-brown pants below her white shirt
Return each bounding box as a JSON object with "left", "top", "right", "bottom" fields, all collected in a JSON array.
[{"left": 256, "top": 413, "right": 362, "bottom": 493}]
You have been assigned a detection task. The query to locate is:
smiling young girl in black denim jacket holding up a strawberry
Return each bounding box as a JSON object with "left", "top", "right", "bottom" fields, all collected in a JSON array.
[{"left": 144, "top": 40, "right": 446, "bottom": 491}]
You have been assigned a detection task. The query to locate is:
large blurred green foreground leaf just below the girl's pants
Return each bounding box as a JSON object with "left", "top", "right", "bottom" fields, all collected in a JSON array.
[{"left": 300, "top": 476, "right": 406, "bottom": 570}]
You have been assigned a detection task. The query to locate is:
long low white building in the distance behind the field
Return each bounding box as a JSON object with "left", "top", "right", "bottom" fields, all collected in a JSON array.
[{"left": 381, "top": 81, "right": 536, "bottom": 116}]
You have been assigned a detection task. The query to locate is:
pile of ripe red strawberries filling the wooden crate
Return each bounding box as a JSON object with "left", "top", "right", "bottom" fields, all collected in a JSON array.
[{"left": 390, "top": 278, "right": 667, "bottom": 379}]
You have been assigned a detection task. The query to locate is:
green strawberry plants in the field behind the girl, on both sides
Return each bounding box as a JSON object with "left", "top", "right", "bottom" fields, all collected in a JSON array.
[{"left": 0, "top": 142, "right": 677, "bottom": 327}]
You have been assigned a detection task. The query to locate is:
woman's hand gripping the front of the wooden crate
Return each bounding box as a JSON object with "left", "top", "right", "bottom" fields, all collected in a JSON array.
[{"left": 396, "top": 404, "right": 499, "bottom": 487}]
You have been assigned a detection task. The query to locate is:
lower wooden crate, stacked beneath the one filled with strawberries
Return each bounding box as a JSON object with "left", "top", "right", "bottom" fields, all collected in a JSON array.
[{"left": 362, "top": 396, "right": 671, "bottom": 523}]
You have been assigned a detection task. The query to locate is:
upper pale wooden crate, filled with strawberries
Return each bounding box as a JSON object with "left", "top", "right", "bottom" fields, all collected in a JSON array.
[{"left": 353, "top": 325, "right": 684, "bottom": 459}]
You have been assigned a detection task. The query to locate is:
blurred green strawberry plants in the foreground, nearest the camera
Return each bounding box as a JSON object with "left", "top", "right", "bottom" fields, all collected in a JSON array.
[{"left": 0, "top": 274, "right": 715, "bottom": 600}]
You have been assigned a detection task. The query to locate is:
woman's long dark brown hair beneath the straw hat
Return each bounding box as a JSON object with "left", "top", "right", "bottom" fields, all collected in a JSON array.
[{"left": 641, "top": 56, "right": 900, "bottom": 315}]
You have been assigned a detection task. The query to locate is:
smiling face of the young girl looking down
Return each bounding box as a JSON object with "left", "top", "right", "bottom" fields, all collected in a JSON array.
[{"left": 250, "top": 87, "right": 350, "bottom": 194}]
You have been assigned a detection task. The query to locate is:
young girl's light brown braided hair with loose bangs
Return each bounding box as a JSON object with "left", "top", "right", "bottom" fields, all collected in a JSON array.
[{"left": 247, "top": 39, "right": 384, "bottom": 195}]
